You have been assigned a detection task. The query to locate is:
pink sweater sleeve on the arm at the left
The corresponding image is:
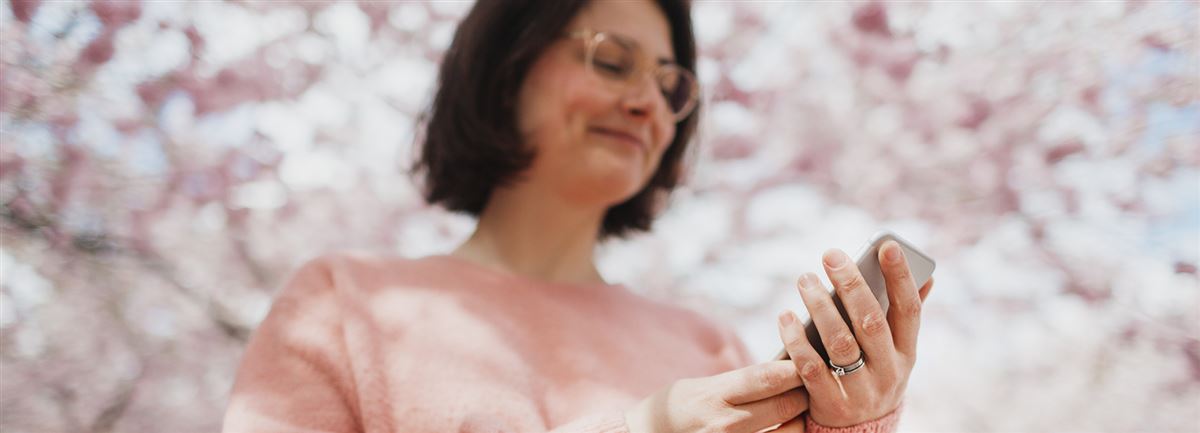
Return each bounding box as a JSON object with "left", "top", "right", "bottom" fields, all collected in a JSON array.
[{"left": 223, "top": 259, "right": 362, "bottom": 433}]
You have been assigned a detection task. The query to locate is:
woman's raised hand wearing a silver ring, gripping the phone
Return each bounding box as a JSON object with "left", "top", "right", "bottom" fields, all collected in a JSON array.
[{"left": 779, "top": 241, "right": 934, "bottom": 427}]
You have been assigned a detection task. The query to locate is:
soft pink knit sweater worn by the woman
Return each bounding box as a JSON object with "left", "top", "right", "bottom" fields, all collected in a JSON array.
[{"left": 224, "top": 254, "right": 896, "bottom": 433}]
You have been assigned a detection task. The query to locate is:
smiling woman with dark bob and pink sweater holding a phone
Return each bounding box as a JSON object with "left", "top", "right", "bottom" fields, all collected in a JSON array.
[{"left": 224, "top": 0, "right": 929, "bottom": 433}]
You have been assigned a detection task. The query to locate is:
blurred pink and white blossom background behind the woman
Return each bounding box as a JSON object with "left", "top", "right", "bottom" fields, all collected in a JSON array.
[{"left": 0, "top": 0, "right": 1200, "bottom": 433}]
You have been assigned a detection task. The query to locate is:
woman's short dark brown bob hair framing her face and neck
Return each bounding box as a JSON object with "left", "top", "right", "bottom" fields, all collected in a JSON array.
[{"left": 412, "top": 0, "right": 700, "bottom": 240}]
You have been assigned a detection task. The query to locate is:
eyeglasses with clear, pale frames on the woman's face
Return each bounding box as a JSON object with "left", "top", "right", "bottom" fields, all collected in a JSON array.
[{"left": 565, "top": 30, "right": 700, "bottom": 122}]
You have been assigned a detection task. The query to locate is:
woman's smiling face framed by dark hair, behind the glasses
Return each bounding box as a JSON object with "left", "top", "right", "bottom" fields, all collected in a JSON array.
[{"left": 517, "top": 0, "right": 676, "bottom": 208}]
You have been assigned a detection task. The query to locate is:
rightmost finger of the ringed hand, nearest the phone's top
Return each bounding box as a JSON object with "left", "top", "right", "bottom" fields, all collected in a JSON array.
[{"left": 880, "top": 241, "right": 920, "bottom": 356}]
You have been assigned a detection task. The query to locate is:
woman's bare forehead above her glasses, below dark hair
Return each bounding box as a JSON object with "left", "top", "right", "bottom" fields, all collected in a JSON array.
[{"left": 569, "top": 0, "right": 674, "bottom": 61}]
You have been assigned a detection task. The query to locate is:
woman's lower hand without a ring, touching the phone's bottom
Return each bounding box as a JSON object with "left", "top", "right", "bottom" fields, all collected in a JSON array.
[{"left": 625, "top": 361, "right": 809, "bottom": 433}]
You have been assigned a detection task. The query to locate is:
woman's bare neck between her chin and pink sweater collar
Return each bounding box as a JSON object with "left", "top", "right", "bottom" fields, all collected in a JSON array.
[{"left": 450, "top": 179, "right": 606, "bottom": 284}]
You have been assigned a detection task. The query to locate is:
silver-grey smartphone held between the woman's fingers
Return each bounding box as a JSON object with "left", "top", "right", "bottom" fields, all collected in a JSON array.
[{"left": 775, "top": 230, "right": 936, "bottom": 362}]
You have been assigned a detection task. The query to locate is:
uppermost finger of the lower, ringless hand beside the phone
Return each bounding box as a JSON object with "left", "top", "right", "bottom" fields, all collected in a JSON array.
[{"left": 716, "top": 361, "right": 804, "bottom": 405}]
